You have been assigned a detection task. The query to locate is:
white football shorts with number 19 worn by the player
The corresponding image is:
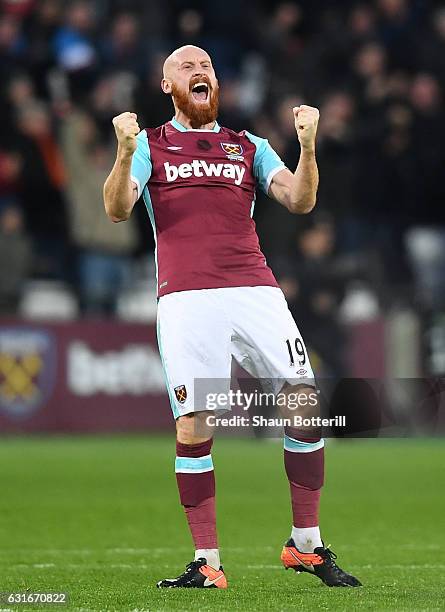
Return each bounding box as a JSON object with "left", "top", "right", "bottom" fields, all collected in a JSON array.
[{"left": 158, "top": 286, "right": 314, "bottom": 418}]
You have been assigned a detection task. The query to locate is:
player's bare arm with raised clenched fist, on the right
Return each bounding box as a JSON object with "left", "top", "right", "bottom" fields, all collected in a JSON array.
[{"left": 269, "top": 104, "right": 320, "bottom": 214}]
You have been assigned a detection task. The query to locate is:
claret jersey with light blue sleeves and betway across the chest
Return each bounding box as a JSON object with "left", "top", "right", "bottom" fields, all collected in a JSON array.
[{"left": 131, "top": 119, "right": 284, "bottom": 297}]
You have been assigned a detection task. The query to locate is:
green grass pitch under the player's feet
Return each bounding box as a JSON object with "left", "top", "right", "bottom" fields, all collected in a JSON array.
[{"left": 0, "top": 436, "right": 445, "bottom": 612}]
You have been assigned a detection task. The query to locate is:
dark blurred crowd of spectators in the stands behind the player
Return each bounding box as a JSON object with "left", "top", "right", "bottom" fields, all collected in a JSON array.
[{"left": 0, "top": 0, "right": 445, "bottom": 370}]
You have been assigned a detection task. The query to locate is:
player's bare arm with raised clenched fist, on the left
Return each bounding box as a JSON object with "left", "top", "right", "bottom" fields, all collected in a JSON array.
[{"left": 104, "top": 113, "right": 140, "bottom": 223}]
